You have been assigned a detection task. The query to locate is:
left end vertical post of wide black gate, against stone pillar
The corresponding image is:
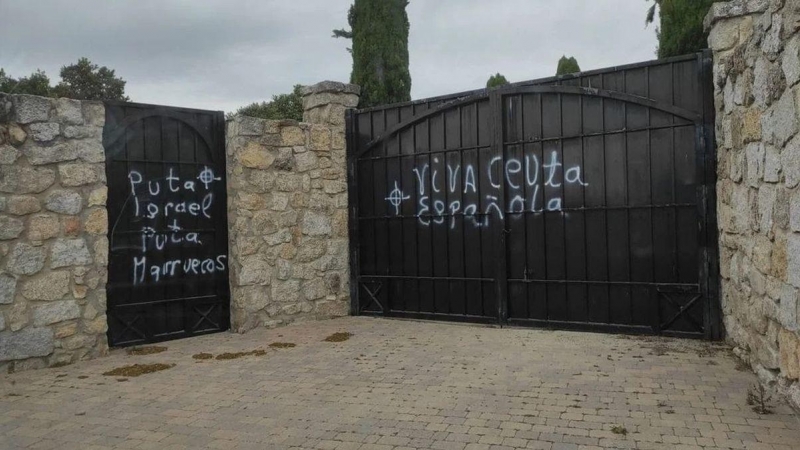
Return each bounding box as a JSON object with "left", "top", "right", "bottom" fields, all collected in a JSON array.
[{"left": 345, "top": 109, "right": 361, "bottom": 316}]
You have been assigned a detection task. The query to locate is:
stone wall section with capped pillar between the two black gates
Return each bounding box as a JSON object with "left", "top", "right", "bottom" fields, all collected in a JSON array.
[{"left": 226, "top": 82, "right": 359, "bottom": 332}]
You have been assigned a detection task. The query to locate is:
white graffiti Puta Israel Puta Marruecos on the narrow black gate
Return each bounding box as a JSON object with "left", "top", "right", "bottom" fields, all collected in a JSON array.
[{"left": 128, "top": 167, "right": 227, "bottom": 286}]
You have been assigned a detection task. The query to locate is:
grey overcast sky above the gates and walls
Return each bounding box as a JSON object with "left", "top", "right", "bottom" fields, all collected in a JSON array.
[{"left": 0, "top": 0, "right": 656, "bottom": 111}]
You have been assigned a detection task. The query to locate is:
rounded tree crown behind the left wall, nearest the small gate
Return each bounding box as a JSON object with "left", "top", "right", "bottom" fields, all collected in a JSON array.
[{"left": 55, "top": 58, "right": 129, "bottom": 101}]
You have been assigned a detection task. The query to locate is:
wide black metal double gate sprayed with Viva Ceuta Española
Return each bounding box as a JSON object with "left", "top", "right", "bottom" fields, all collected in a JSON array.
[{"left": 348, "top": 53, "right": 721, "bottom": 338}]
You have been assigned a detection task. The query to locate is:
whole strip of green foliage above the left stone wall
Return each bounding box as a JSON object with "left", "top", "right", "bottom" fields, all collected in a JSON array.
[{"left": 0, "top": 58, "right": 129, "bottom": 101}]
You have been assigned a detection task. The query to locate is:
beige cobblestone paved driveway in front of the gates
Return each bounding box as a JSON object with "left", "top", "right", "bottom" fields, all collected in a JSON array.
[{"left": 0, "top": 318, "right": 800, "bottom": 450}]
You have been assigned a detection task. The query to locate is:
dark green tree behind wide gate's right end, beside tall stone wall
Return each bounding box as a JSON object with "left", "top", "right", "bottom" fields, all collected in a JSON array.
[{"left": 645, "top": 0, "right": 715, "bottom": 58}]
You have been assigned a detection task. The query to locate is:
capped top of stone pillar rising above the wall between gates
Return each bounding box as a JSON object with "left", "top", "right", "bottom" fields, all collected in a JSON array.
[{"left": 303, "top": 81, "right": 361, "bottom": 128}]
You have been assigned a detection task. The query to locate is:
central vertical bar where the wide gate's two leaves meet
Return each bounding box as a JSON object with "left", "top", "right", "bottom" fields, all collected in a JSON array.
[{"left": 489, "top": 91, "right": 508, "bottom": 326}]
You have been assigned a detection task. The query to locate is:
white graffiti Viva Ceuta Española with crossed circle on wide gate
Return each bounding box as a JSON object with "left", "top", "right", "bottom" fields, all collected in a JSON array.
[{"left": 385, "top": 151, "right": 589, "bottom": 228}]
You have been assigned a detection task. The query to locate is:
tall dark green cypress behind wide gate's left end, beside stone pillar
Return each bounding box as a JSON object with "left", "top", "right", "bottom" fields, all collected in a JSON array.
[{"left": 333, "top": 0, "right": 411, "bottom": 108}]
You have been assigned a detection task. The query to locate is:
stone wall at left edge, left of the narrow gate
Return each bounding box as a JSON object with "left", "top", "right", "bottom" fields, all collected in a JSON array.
[{"left": 0, "top": 94, "right": 108, "bottom": 371}]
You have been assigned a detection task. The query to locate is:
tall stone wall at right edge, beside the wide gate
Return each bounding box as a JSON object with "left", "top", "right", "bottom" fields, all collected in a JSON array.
[{"left": 706, "top": 0, "right": 800, "bottom": 405}]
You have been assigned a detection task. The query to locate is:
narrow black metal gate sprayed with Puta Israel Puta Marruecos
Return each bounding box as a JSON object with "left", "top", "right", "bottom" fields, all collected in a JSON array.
[{"left": 103, "top": 102, "right": 230, "bottom": 346}]
